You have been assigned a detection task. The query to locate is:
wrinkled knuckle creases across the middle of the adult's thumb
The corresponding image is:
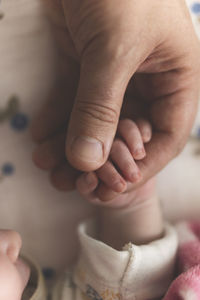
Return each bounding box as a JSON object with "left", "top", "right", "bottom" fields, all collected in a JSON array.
[{"left": 77, "top": 101, "right": 119, "bottom": 125}]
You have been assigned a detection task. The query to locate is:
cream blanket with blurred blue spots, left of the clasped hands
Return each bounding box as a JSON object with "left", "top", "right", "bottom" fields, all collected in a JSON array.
[{"left": 0, "top": 0, "right": 95, "bottom": 277}]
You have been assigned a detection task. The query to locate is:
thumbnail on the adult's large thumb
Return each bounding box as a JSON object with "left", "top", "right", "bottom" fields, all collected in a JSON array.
[{"left": 71, "top": 136, "right": 103, "bottom": 162}]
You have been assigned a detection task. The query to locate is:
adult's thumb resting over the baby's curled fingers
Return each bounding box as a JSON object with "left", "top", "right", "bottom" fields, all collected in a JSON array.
[{"left": 66, "top": 57, "right": 130, "bottom": 171}]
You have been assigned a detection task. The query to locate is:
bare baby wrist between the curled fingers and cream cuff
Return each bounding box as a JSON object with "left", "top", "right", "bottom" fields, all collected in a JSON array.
[{"left": 99, "top": 179, "right": 164, "bottom": 250}]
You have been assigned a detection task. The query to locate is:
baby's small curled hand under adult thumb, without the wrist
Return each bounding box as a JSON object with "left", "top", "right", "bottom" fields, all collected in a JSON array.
[{"left": 76, "top": 119, "right": 152, "bottom": 206}]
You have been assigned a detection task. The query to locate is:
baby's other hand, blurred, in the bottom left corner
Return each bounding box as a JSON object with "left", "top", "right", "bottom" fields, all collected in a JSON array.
[{"left": 0, "top": 230, "right": 30, "bottom": 300}]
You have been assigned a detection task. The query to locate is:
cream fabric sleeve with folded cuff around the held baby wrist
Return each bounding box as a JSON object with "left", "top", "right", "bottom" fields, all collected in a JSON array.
[{"left": 53, "top": 220, "right": 177, "bottom": 300}]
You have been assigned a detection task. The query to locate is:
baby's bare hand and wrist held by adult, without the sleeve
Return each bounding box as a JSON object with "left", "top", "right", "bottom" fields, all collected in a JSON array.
[{"left": 77, "top": 119, "right": 164, "bottom": 250}]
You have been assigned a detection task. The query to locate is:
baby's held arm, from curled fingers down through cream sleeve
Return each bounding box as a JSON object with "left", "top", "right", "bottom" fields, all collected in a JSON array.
[{"left": 53, "top": 120, "right": 177, "bottom": 300}]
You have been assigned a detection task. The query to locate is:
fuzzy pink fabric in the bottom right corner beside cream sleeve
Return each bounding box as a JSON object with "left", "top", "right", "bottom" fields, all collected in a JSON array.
[{"left": 163, "top": 222, "right": 200, "bottom": 300}]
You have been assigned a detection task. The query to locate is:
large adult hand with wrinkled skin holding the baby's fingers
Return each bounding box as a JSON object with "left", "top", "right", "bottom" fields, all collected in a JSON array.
[{"left": 33, "top": 0, "right": 200, "bottom": 190}]
